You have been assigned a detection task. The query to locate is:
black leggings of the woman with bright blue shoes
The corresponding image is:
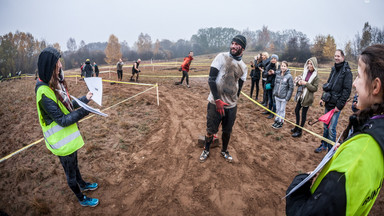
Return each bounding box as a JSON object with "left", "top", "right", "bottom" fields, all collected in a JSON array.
[{"left": 59, "top": 151, "right": 86, "bottom": 201}]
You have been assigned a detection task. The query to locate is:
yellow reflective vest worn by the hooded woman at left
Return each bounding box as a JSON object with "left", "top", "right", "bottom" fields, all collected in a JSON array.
[{"left": 36, "top": 85, "right": 84, "bottom": 156}]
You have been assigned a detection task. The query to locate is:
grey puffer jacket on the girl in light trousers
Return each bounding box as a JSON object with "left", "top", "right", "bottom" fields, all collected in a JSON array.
[{"left": 273, "top": 69, "right": 293, "bottom": 101}]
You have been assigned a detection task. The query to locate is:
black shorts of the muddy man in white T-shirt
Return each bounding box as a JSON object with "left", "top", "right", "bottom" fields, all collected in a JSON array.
[{"left": 207, "top": 103, "right": 237, "bottom": 134}]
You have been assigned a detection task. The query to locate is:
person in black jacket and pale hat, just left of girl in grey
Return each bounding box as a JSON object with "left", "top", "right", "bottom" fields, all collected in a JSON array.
[{"left": 263, "top": 54, "right": 279, "bottom": 119}]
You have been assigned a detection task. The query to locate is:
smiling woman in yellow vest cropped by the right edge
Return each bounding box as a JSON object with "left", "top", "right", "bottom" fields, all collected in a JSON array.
[{"left": 286, "top": 44, "right": 384, "bottom": 215}]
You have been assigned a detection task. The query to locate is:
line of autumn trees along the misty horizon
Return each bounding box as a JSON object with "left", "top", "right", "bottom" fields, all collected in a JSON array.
[{"left": 0, "top": 22, "right": 384, "bottom": 77}]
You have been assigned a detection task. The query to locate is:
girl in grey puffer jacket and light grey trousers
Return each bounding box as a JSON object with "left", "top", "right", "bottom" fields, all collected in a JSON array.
[{"left": 272, "top": 61, "right": 293, "bottom": 129}]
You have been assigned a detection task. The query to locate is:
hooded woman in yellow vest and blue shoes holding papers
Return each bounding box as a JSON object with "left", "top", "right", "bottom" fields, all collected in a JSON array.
[{"left": 35, "top": 47, "right": 99, "bottom": 207}]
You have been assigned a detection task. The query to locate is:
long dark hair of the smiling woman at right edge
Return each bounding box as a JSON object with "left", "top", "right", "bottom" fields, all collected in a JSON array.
[{"left": 343, "top": 44, "right": 384, "bottom": 140}]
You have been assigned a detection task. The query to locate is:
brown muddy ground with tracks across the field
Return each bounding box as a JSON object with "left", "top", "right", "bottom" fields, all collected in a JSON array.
[{"left": 0, "top": 61, "right": 384, "bottom": 215}]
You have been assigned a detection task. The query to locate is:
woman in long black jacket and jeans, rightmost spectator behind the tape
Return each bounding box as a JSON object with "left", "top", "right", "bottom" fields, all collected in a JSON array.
[{"left": 315, "top": 49, "right": 352, "bottom": 153}]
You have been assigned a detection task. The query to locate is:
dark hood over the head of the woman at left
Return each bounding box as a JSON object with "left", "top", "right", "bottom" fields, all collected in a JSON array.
[{"left": 37, "top": 47, "right": 61, "bottom": 83}]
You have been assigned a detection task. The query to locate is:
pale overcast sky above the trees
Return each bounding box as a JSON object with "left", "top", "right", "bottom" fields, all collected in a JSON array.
[{"left": 0, "top": 0, "right": 384, "bottom": 50}]
